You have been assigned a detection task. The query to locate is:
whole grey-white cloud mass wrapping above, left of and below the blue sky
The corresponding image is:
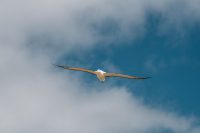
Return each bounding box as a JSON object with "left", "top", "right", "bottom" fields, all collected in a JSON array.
[{"left": 0, "top": 0, "right": 199, "bottom": 133}]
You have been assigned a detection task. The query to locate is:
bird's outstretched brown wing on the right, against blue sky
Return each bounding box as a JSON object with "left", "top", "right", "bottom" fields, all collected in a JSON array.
[{"left": 104, "top": 73, "right": 150, "bottom": 79}]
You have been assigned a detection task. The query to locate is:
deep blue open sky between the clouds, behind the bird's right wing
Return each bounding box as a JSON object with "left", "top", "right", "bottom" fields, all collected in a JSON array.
[{"left": 63, "top": 14, "right": 200, "bottom": 117}]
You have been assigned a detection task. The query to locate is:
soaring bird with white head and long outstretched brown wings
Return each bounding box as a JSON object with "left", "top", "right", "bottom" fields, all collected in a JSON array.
[{"left": 56, "top": 65, "right": 150, "bottom": 82}]
